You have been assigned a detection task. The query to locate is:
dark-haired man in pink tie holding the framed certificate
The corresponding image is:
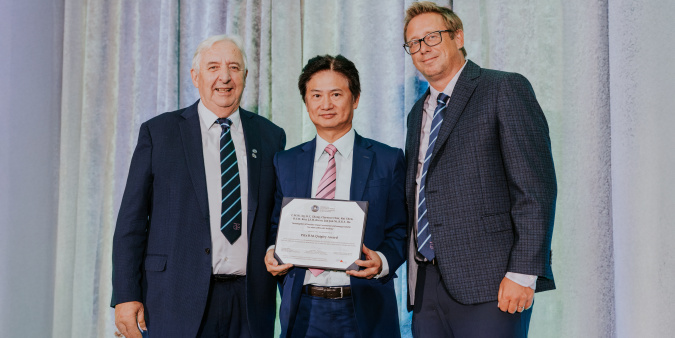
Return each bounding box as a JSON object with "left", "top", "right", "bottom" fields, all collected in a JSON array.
[{"left": 265, "top": 55, "right": 407, "bottom": 337}]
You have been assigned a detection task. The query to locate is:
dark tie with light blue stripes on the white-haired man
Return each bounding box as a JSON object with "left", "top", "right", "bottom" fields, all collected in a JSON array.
[{"left": 216, "top": 119, "right": 241, "bottom": 243}]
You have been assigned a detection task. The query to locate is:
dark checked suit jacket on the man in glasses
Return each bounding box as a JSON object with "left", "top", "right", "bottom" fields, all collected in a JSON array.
[{"left": 406, "top": 61, "right": 556, "bottom": 304}]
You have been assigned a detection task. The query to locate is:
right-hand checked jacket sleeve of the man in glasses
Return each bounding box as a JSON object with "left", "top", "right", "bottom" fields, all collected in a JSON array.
[{"left": 497, "top": 74, "right": 557, "bottom": 278}]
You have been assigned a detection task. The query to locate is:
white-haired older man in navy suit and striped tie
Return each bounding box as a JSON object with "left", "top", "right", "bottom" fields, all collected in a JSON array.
[{"left": 112, "top": 35, "right": 286, "bottom": 338}]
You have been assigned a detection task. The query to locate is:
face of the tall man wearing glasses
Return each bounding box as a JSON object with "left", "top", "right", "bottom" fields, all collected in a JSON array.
[{"left": 406, "top": 13, "right": 464, "bottom": 90}]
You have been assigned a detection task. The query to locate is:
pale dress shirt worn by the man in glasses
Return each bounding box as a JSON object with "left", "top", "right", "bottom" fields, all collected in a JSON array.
[{"left": 415, "top": 62, "right": 537, "bottom": 289}]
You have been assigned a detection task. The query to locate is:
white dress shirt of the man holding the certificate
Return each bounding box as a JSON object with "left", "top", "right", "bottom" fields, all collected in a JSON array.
[{"left": 304, "top": 129, "right": 389, "bottom": 286}]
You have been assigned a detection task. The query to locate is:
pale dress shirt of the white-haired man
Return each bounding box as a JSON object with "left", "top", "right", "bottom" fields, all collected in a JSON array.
[{"left": 197, "top": 101, "right": 248, "bottom": 275}]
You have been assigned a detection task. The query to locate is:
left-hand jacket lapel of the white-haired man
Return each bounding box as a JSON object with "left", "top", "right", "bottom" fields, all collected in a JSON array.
[{"left": 178, "top": 101, "right": 209, "bottom": 218}]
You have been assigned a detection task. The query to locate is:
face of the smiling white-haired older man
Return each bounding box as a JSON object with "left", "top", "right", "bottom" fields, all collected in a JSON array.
[{"left": 190, "top": 41, "right": 248, "bottom": 117}]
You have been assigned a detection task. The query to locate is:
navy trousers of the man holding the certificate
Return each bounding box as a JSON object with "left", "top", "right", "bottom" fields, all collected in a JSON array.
[{"left": 291, "top": 294, "right": 359, "bottom": 338}]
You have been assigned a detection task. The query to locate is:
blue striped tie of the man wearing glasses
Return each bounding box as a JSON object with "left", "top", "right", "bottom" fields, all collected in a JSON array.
[{"left": 417, "top": 93, "right": 450, "bottom": 261}]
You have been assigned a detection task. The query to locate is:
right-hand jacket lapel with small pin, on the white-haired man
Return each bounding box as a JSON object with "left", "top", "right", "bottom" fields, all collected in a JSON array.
[{"left": 239, "top": 107, "right": 262, "bottom": 239}]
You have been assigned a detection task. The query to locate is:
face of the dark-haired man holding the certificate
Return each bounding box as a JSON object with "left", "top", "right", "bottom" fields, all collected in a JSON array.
[{"left": 305, "top": 70, "right": 359, "bottom": 138}]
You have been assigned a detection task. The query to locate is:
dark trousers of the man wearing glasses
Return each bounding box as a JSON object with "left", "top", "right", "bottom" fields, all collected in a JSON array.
[{"left": 412, "top": 264, "right": 532, "bottom": 338}]
